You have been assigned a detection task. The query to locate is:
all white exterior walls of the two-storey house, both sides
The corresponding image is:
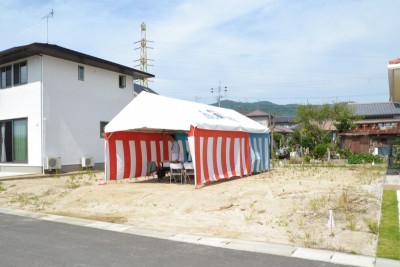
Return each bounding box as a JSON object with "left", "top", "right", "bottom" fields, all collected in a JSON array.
[{"left": 0, "top": 55, "right": 138, "bottom": 172}]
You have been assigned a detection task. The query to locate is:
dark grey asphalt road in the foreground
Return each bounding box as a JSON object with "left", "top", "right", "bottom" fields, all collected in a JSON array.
[{"left": 0, "top": 214, "right": 354, "bottom": 267}]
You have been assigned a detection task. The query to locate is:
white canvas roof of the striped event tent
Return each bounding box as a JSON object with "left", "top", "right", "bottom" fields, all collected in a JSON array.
[{"left": 105, "top": 92, "right": 268, "bottom": 133}]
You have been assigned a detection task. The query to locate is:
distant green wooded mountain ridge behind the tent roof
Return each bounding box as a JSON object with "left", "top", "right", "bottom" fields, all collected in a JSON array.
[{"left": 211, "top": 100, "right": 297, "bottom": 116}]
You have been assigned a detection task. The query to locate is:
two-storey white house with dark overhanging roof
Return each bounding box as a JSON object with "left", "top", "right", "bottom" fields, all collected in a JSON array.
[{"left": 0, "top": 43, "right": 154, "bottom": 173}]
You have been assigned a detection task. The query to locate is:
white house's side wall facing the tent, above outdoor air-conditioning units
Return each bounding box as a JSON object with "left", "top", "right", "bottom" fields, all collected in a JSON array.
[{"left": 43, "top": 56, "right": 133, "bottom": 169}]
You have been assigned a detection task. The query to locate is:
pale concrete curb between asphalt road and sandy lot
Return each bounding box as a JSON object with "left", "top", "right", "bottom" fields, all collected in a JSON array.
[{"left": 0, "top": 208, "right": 400, "bottom": 267}]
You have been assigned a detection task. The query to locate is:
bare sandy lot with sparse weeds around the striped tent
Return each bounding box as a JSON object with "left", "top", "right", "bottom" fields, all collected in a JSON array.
[{"left": 0, "top": 166, "right": 386, "bottom": 256}]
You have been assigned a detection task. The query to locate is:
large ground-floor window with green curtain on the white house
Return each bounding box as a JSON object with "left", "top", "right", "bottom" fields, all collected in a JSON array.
[{"left": 0, "top": 119, "right": 28, "bottom": 163}]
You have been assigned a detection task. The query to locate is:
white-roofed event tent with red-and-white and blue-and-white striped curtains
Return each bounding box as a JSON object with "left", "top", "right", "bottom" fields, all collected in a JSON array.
[{"left": 105, "top": 92, "right": 270, "bottom": 186}]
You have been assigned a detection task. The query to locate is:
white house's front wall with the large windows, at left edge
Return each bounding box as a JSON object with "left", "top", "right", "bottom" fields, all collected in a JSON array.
[{"left": 0, "top": 57, "right": 42, "bottom": 172}]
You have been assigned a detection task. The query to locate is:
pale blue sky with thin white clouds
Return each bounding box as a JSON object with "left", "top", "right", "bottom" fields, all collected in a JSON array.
[{"left": 0, "top": 0, "right": 400, "bottom": 104}]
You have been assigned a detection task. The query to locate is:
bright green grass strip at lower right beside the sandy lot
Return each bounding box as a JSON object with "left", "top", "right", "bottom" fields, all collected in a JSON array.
[{"left": 376, "top": 190, "right": 400, "bottom": 260}]
